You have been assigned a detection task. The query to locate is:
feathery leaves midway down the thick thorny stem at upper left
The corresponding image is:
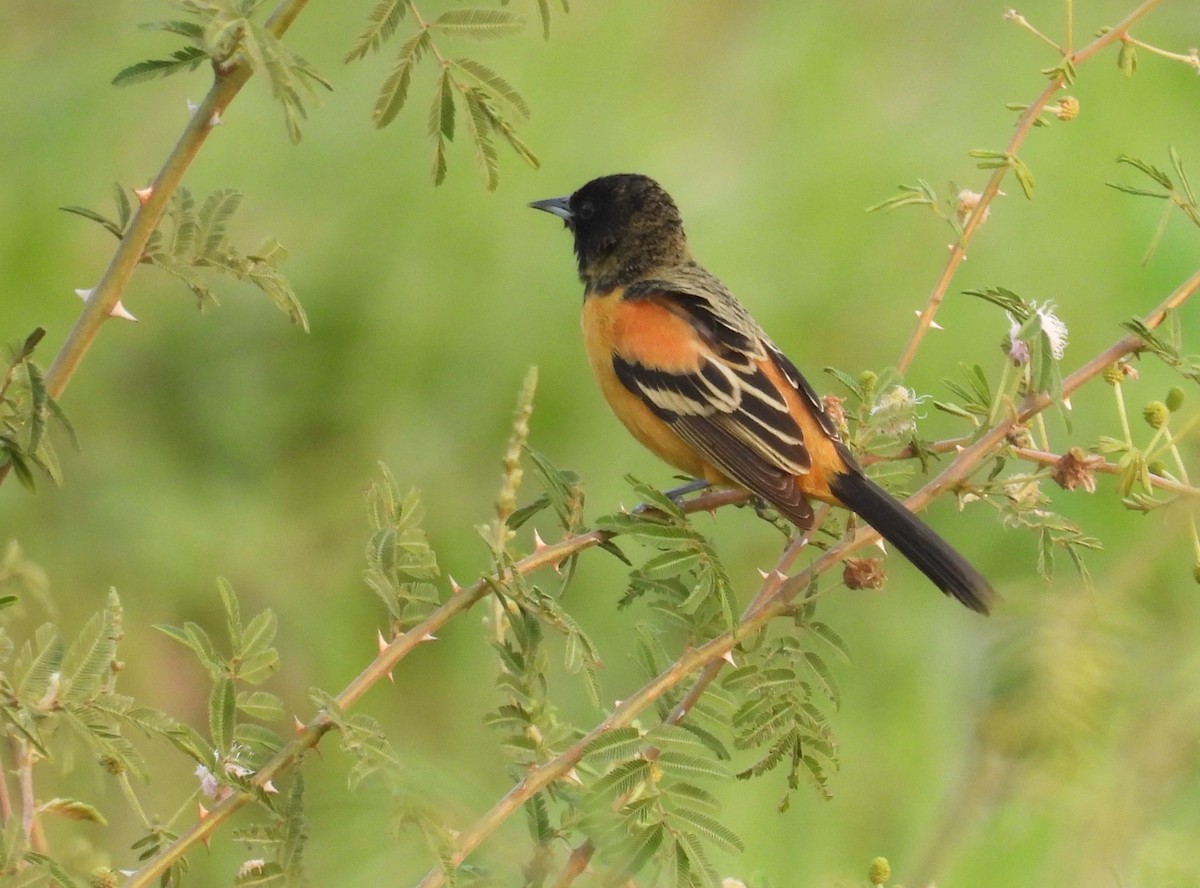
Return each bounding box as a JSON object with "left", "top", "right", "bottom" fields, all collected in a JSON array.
[{"left": 61, "top": 185, "right": 308, "bottom": 331}]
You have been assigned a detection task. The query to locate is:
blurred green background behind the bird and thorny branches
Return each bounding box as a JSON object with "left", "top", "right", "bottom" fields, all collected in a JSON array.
[{"left": 0, "top": 0, "right": 1200, "bottom": 886}]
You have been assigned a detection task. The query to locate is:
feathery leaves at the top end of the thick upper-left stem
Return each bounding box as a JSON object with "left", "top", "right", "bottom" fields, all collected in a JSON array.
[{"left": 113, "top": 0, "right": 332, "bottom": 142}]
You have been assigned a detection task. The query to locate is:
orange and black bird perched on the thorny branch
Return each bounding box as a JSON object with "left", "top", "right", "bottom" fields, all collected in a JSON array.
[{"left": 529, "top": 174, "right": 995, "bottom": 613}]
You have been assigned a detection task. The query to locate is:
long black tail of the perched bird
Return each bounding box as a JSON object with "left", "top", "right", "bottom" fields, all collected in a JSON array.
[{"left": 829, "top": 472, "right": 996, "bottom": 614}]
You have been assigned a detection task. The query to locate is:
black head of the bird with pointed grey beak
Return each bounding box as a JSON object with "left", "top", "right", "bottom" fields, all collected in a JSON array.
[{"left": 529, "top": 173, "right": 691, "bottom": 292}]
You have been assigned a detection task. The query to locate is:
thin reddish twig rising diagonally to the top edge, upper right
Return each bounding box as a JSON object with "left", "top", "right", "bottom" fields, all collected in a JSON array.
[{"left": 896, "top": 0, "right": 1162, "bottom": 373}]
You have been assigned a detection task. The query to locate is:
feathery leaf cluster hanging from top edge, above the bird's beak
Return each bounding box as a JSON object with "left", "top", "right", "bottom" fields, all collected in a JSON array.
[{"left": 346, "top": 0, "right": 554, "bottom": 190}]
